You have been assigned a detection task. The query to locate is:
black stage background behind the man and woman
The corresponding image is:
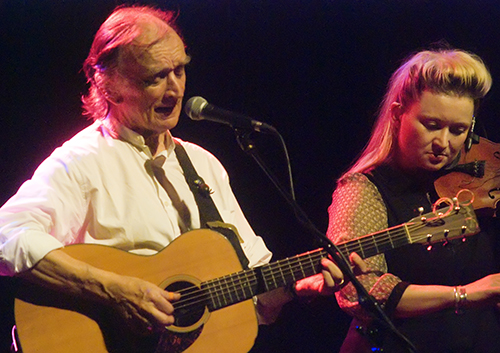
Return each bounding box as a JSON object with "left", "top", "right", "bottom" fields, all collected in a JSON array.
[{"left": 0, "top": 0, "right": 500, "bottom": 352}]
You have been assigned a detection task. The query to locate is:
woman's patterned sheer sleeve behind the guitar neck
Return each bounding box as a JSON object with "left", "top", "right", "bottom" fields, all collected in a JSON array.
[{"left": 327, "top": 173, "right": 401, "bottom": 319}]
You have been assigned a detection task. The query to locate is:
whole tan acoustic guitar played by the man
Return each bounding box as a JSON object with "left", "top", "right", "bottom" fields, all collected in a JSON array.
[{"left": 15, "top": 202, "right": 479, "bottom": 353}]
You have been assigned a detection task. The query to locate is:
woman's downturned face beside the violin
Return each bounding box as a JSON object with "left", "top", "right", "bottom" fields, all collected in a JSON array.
[{"left": 393, "top": 91, "right": 474, "bottom": 172}]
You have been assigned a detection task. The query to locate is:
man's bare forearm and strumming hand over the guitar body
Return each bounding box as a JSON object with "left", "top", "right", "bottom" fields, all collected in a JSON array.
[{"left": 20, "top": 250, "right": 180, "bottom": 334}]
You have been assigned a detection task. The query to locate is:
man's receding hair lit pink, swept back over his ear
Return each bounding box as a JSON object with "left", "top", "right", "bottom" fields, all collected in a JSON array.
[{"left": 82, "top": 6, "right": 179, "bottom": 120}]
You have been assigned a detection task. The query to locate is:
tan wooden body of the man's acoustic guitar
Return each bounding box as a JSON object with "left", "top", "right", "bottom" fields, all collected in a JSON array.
[{"left": 15, "top": 229, "right": 257, "bottom": 353}]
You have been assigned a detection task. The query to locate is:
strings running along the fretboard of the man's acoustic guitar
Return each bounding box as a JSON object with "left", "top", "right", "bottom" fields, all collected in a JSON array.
[{"left": 174, "top": 223, "right": 464, "bottom": 309}]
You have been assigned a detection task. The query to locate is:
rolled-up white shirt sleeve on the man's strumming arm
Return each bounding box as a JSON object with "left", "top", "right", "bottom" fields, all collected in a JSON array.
[{"left": 0, "top": 155, "right": 84, "bottom": 276}]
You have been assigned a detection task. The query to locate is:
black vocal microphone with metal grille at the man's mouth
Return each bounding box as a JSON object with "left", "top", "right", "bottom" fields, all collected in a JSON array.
[{"left": 184, "top": 97, "right": 276, "bottom": 133}]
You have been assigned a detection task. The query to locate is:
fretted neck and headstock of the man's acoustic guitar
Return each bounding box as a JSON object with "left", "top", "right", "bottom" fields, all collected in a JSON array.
[{"left": 195, "top": 206, "right": 479, "bottom": 311}]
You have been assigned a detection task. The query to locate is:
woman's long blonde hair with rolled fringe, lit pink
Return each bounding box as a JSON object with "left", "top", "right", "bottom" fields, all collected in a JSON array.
[{"left": 346, "top": 49, "right": 492, "bottom": 174}]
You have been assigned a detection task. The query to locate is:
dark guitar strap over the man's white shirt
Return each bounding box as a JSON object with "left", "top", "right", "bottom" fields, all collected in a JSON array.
[{"left": 175, "top": 142, "right": 248, "bottom": 269}]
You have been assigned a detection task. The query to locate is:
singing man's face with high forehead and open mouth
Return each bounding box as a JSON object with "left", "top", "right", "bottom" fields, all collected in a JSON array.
[{"left": 111, "top": 24, "right": 189, "bottom": 134}]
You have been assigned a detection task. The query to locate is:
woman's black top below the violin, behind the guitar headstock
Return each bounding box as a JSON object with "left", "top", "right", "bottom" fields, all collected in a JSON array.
[{"left": 368, "top": 166, "right": 500, "bottom": 353}]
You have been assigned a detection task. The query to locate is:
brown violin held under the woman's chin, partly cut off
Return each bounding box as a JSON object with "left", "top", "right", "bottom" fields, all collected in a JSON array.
[{"left": 434, "top": 136, "right": 500, "bottom": 216}]
